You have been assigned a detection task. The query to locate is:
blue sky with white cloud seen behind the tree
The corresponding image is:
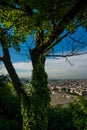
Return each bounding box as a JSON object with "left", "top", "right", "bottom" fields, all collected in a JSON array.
[{"left": 0, "top": 28, "right": 87, "bottom": 79}]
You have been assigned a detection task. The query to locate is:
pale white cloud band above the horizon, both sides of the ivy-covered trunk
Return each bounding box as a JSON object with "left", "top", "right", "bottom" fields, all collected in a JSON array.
[{"left": 0, "top": 55, "right": 87, "bottom": 79}]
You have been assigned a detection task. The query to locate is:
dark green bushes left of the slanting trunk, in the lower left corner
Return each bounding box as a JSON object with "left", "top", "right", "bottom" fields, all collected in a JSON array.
[{"left": 0, "top": 76, "right": 21, "bottom": 130}]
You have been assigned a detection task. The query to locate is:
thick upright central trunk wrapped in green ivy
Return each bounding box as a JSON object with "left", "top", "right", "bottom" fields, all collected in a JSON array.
[{"left": 24, "top": 50, "right": 50, "bottom": 130}]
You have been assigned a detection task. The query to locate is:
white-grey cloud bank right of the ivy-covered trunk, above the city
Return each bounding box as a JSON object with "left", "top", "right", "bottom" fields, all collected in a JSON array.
[{"left": 46, "top": 55, "right": 87, "bottom": 79}]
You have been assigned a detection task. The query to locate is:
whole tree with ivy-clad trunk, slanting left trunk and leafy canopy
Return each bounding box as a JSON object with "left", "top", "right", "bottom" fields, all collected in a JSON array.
[{"left": 0, "top": 0, "right": 87, "bottom": 130}]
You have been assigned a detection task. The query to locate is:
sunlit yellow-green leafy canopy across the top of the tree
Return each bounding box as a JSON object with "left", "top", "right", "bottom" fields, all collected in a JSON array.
[{"left": 0, "top": 0, "right": 87, "bottom": 53}]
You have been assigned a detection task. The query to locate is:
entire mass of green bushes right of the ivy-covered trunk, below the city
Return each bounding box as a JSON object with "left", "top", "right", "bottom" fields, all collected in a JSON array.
[{"left": 48, "top": 97, "right": 87, "bottom": 130}]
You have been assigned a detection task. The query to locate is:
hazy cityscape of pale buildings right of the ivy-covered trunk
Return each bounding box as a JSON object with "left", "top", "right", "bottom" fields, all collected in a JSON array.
[{"left": 48, "top": 80, "right": 87, "bottom": 106}]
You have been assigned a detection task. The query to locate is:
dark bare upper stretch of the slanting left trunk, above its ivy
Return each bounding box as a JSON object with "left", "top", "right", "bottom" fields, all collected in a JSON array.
[{"left": 1, "top": 42, "right": 30, "bottom": 103}]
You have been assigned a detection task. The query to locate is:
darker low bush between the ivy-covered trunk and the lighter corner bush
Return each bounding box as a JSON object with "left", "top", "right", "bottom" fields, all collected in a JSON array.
[{"left": 48, "top": 106, "right": 77, "bottom": 130}]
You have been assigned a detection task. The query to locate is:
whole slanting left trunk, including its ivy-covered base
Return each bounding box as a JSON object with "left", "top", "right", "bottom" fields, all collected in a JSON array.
[{"left": 2, "top": 44, "right": 30, "bottom": 130}]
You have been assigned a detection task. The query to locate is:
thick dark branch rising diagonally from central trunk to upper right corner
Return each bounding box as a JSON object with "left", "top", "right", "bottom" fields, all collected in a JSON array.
[{"left": 37, "top": 0, "right": 87, "bottom": 54}]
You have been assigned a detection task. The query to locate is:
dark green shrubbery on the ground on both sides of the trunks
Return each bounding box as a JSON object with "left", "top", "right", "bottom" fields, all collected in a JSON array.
[{"left": 0, "top": 76, "right": 87, "bottom": 130}]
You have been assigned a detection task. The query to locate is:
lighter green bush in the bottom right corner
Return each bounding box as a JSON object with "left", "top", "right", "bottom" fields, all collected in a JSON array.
[{"left": 69, "top": 96, "right": 87, "bottom": 130}]
